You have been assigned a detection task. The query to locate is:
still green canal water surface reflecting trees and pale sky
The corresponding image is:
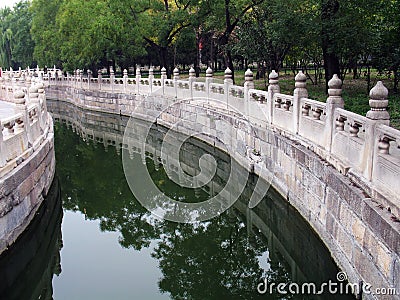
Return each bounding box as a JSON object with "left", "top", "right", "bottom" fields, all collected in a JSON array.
[{"left": 0, "top": 102, "right": 356, "bottom": 299}]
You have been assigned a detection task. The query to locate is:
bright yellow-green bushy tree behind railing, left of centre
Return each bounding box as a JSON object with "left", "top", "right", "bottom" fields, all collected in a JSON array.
[{"left": 57, "top": 0, "right": 144, "bottom": 70}]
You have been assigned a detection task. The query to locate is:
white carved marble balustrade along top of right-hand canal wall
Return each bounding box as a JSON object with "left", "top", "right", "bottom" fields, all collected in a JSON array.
[{"left": 2, "top": 68, "right": 400, "bottom": 217}]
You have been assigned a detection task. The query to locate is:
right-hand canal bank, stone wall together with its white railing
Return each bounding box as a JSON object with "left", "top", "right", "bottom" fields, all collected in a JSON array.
[{"left": 45, "top": 68, "right": 400, "bottom": 298}]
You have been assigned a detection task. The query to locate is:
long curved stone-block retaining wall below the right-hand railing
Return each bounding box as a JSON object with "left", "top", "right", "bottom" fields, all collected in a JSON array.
[{"left": 48, "top": 81, "right": 400, "bottom": 299}]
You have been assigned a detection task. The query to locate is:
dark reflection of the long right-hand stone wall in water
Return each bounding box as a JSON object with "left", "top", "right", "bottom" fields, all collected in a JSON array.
[{"left": 48, "top": 101, "right": 337, "bottom": 296}]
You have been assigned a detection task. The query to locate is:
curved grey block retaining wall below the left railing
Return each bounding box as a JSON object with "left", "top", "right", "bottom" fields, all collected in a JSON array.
[{"left": 0, "top": 115, "right": 55, "bottom": 254}]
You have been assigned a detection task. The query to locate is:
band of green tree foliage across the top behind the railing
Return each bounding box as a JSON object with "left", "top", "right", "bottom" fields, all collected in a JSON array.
[{"left": 0, "top": 0, "right": 400, "bottom": 89}]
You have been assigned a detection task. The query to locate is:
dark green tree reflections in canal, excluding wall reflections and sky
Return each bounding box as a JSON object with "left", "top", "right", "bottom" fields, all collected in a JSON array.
[{"left": 55, "top": 124, "right": 350, "bottom": 299}]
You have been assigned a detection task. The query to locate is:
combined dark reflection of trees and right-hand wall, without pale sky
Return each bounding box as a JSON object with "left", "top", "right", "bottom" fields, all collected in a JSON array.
[{"left": 49, "top": 101, "right": 354, "bottom": 299}]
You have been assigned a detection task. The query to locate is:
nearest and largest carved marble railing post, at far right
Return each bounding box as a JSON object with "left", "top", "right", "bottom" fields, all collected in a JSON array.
[{"left": 362, "top": 81, "right": 390, "bottom": 180}]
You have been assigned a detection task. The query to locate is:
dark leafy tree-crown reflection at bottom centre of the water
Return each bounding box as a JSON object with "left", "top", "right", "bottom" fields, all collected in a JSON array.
[{"left": 153, "top": 209, "right": 296, "bottom": 299}]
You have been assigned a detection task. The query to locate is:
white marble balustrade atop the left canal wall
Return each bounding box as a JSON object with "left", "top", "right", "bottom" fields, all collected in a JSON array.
[{"left": 0, "top": 77, "right": 52, "bottom": 178}]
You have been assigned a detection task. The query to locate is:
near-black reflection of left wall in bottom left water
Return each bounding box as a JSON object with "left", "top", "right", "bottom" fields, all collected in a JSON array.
[{"left": 0, "top": 179, "right": 62, "bottom": 300}]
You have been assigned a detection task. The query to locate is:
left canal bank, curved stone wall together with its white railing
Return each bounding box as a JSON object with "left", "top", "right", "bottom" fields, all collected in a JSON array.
[{"left": 0, "top": 77, "right": 55, "bottom": 254}]
